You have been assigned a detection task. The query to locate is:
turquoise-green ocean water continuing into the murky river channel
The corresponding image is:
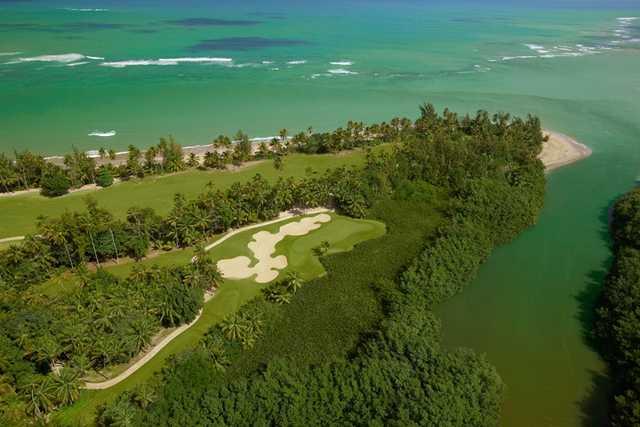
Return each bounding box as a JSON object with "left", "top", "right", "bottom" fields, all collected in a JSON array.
[{"left": 0, "top": 0, "right": 640, "bottom": 426}]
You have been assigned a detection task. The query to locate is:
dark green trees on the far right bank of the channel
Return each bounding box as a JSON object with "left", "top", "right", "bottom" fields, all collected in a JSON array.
[{"left": 595, "top": 188, "right": 640, "bottom": 427}]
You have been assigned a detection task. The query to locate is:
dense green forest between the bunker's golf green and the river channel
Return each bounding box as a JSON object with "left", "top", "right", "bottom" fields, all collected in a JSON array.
[{"left": 84, "top": 105, "right": 545, "bottom": 426}]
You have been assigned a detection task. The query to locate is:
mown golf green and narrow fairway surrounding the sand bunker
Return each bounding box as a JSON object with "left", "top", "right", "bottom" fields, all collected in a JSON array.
[{"left": 53, "top": 214, "right": 385, "bottom": 425}]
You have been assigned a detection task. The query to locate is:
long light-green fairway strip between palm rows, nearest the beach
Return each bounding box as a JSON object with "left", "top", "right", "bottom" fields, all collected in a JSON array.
[{"left": 0, "top": 150, "right": 376, "bottom": 238}]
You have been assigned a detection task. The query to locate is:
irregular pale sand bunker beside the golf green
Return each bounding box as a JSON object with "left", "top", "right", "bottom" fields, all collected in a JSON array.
[{"left": 218, "top": 214, "right": 331, "bottom": 283}]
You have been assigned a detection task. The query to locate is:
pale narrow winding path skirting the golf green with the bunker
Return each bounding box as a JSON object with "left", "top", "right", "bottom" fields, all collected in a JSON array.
[{"left": 81, "top": 208, "right": 330, "bottom": 390}]
